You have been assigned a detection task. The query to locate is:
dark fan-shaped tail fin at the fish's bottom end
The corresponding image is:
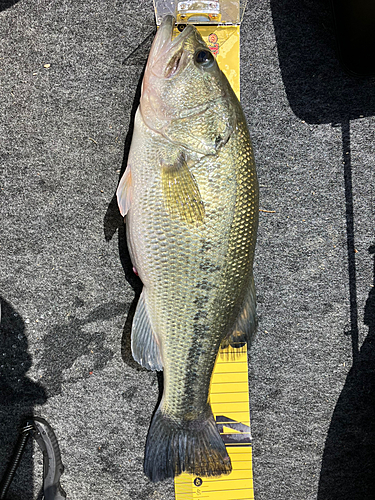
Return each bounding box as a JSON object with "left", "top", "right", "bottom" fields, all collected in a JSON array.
[{"left": 143, "top": 408, "right": 232, "bottom": 482}]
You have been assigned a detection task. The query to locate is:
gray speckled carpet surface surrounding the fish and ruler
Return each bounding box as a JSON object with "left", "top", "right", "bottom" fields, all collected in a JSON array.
[{"left": 0, "top": 0, "right": 375, "bottom": 500}]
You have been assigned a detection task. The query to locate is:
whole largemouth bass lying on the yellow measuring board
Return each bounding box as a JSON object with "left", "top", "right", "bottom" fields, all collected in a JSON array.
[{"left": 117, "top": 16, "right": 259, "bottom": 482}]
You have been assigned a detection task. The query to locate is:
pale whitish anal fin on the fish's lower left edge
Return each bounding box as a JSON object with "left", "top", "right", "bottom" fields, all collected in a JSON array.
[{"left": 131, "top": 289, "right": 163, "bottom": 371}]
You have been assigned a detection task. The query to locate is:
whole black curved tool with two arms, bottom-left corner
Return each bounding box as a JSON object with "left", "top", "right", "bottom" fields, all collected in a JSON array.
[{"left": 0, "top": 417, "right": 66, "bottom": 500}]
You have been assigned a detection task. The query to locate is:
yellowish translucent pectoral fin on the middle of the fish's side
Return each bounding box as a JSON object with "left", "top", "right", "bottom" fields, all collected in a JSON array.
[{"left": 161, "top": 154, "right": 204, "bottom": 224}]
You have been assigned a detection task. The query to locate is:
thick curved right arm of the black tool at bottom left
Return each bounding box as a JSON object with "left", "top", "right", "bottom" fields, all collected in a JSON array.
[{"left": 33, "top": 417, "right": 66, "bottom": 500}]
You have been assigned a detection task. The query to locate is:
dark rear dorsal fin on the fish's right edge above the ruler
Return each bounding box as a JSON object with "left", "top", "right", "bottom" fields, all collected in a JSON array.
[{"left": 221, "top": 277, "right": 258, "bottom": 348}]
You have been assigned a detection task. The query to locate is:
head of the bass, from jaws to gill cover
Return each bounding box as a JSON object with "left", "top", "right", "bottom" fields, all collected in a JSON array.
[{"left": 140, "top": 16, "right": 236, "bottom": 154}]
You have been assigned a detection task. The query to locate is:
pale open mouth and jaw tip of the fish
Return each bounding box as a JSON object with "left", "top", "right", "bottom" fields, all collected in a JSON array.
[{"left": 146, "top": 15, "right": 196, "bottom": 78}]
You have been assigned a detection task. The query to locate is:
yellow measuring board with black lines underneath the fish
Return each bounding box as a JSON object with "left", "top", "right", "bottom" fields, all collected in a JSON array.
[{"left": 175, "top": 21, "right": 254, "bottom": 500}]
